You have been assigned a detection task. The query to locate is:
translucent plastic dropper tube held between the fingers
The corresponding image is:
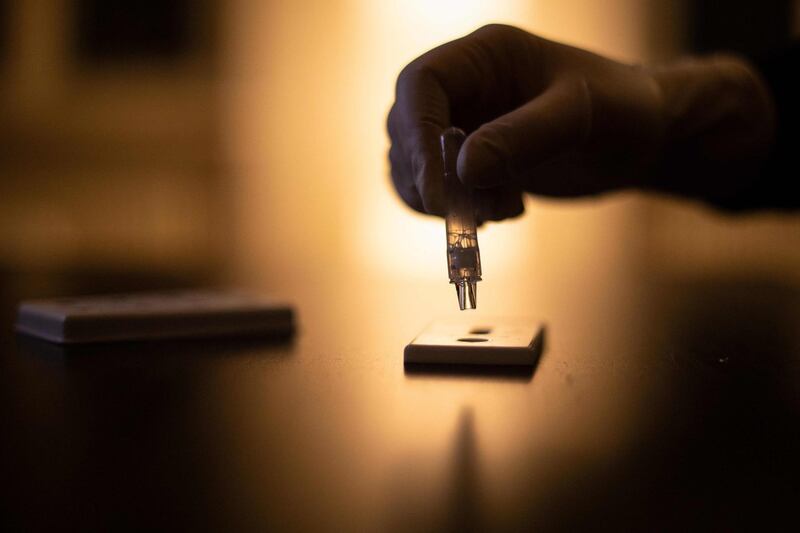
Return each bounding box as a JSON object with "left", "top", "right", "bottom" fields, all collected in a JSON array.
[{"left": 441, "top": 128, "right": 481, "bottom": 311}]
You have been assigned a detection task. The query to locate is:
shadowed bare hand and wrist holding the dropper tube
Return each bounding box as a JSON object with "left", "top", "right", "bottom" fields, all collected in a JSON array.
[{"left": 388, "top": 25, "right": 774, "bottom": 221}]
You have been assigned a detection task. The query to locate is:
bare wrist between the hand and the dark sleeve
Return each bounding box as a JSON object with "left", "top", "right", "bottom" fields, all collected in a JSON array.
[{"left": 646, "top": 54, "right": 775, "bottom": 201}]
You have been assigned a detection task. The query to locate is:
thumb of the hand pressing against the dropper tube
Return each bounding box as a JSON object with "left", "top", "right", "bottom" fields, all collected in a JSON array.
[{"left": 458, "top": 79, "right": 591, "bottom": 188}]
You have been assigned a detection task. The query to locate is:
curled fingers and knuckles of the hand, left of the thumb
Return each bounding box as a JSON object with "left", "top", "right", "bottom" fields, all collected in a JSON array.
[{"left": 388, "top": 25, "right": 531, "bottom": 215}]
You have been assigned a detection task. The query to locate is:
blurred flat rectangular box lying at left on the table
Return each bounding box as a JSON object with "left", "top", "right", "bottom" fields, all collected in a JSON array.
[{"left": 16, "top": 291, "right": 294, "bottom": 344}]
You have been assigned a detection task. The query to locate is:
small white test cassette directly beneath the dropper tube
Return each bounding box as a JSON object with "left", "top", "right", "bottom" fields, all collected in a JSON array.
[{"left": 403, "top": 318, "right": 545, "bottom": 366}]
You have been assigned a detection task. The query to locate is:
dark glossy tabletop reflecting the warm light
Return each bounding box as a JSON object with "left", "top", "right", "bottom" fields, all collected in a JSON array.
[{"left": 0, "top": 251, "right": 800, "bottom": 531}]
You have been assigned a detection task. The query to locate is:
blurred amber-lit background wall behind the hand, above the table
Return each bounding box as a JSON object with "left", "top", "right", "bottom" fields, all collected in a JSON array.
[{"left": 0, "top": 0, "right": 800, "bottom": 296}]
